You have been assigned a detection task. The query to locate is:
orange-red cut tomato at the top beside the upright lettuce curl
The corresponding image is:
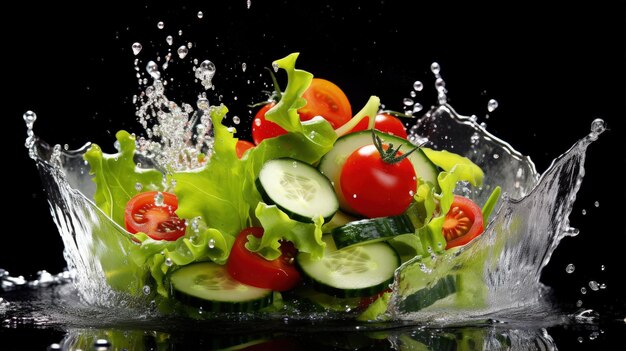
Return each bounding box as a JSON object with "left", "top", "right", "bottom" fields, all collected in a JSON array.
[{"left": 298, "top": 78, "right": 352, "bottom": 129}]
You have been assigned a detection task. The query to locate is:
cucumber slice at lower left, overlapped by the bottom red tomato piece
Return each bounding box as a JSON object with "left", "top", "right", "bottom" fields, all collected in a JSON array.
[{"left": 169, "top": 262, "right": 273, "bottom": 312}]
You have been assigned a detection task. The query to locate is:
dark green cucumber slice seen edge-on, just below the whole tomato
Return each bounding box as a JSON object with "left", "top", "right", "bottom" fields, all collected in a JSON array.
[{"left": 331, "top": 215, "right": 415, "bottom": 249}]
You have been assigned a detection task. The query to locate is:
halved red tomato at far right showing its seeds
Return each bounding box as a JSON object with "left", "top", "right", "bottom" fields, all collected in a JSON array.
[{"left": 443, "top": 195, "right": 483, "bottom": 249}]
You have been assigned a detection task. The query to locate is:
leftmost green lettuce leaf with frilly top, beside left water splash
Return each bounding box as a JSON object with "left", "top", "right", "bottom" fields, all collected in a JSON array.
[{"left": 84, "top": 130, "right": 163, "bottom": 227}]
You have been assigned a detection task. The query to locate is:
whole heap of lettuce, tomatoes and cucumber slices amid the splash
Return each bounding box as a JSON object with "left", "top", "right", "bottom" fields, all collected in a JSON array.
[{"left": 85, "top": 53, "right": 499, "bottom": 320}]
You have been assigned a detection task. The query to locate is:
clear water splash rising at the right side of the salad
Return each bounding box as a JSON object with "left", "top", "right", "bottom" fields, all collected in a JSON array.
[{"left": 388, "top": 105, "right": 605, "bottom": 321}]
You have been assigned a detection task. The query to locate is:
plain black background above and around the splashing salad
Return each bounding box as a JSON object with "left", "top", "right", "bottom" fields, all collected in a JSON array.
[{"left": 0, "top": 0, "right": 626, "bottom": 346}]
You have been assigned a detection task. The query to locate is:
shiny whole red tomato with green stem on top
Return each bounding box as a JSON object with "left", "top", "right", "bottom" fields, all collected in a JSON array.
[{"left": 339, "top": 144, "right": 417, "bottom": 218}]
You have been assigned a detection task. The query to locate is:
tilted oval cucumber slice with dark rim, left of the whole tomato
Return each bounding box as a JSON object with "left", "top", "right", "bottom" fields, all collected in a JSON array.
[{"left": 256, "top": 158, "right": 339, "bottom": 223}]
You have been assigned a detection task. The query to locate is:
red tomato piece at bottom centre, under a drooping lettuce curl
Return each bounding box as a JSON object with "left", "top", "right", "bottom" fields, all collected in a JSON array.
[{"left": 226, "top": 227, "right": 300, "bottom": 291}]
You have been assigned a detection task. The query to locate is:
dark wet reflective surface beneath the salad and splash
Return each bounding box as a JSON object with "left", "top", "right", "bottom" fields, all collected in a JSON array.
[{"left": 0, "top": 284, "right": 626, "bottom": 351}]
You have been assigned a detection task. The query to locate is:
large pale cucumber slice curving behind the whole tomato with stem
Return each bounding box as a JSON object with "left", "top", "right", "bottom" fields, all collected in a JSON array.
[{"left": 318, "top": 130, "right": 439, "bottom": 213}]
